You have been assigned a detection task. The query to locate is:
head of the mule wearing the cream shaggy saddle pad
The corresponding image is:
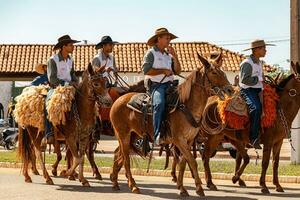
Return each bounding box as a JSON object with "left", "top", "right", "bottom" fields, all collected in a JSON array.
[{"left": 83, "top": 63, "right": 112, "bottom": 107}]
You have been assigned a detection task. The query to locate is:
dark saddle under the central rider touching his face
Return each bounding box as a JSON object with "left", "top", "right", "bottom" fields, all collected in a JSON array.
[{"left": 127, "top": 93, "right": 179, "bottom": 115}]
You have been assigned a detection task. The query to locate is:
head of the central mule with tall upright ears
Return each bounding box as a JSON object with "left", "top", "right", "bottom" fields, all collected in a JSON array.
[{"left": 198, "top": 54, "right": 234, "bottom": 99}]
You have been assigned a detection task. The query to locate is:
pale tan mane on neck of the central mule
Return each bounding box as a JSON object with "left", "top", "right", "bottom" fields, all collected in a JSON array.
[{"left": 177, "top": 70, "right": 197, "bottom": 103}]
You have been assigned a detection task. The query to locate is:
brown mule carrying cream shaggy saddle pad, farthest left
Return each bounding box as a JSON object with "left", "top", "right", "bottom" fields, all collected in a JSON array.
[{"left": 18, "top": 64, "right": 111, "bottom": 186}]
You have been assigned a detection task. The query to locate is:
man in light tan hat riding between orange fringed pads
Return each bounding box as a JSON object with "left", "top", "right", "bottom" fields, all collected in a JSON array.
[{"left": 240, "top": 40, "right": 270, "bottom": 149}]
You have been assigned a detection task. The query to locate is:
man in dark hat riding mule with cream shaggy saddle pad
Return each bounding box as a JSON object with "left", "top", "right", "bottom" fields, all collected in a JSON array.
[{"left": 42, "top": 35, "right": 80, "bottom": 145}]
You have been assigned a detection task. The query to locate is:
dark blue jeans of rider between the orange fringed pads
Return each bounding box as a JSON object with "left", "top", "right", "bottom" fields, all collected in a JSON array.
[{"left": 241, "top": 88, "right": 262, "bottom": 142}]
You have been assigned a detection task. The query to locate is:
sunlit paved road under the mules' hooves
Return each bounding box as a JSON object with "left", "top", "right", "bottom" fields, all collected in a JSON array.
[{"left": 0, "top": 168, "right": 300, "bottom": 200}]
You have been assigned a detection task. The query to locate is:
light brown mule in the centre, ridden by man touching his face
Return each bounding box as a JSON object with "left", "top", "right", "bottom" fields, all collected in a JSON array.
[{"left": 110, "top": 55, "right": 231, "bottom": 196}]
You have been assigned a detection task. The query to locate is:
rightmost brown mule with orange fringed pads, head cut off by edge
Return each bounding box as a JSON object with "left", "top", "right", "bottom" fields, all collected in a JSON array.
[{"left": 172, "top": 63, "right": 300, "bottom": 193}]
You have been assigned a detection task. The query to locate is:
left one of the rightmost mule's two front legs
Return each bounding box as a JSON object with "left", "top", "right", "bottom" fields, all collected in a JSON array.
[{"left": 259, "top": 144, "right": 271, "bottom": 194}]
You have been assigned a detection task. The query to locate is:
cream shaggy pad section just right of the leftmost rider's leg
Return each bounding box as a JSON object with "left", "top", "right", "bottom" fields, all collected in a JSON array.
[{"left": 47, "top": 86, "right": 75, "bottom": 126}]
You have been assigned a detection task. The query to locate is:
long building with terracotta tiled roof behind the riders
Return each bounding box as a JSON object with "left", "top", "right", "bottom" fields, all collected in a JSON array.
[{"left": 0, "top": 42, "right": 271, "bottom": 117}]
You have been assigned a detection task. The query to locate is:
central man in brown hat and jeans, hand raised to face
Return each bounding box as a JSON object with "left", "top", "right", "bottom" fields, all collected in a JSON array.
[{"left": 142, "top": 28, "right": 181, "bottom": 145}]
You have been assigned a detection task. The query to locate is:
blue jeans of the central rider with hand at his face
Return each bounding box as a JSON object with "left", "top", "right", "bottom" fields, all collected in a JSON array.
[{"left": 150, "top": 82, "right": 170, "bottom": 139}]
